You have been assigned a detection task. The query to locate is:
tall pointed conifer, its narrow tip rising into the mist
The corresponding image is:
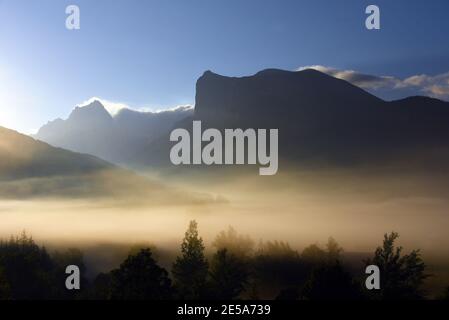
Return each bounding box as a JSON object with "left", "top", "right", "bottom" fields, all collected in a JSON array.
[{"left": 172, "top": 220, "right": 208, "bottom": 299}]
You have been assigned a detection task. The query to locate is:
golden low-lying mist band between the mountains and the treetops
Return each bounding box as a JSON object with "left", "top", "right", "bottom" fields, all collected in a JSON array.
[{"left": 0, "top": 168, "right": 449, "bottom": 296}]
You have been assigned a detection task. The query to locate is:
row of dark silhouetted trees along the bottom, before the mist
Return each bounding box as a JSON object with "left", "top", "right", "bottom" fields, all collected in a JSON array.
[{"left": 0, "top": 221, "right": 449, "bottom": 300}]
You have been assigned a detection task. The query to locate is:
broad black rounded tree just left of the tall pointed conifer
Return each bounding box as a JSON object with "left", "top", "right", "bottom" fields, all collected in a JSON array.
[{"left": 111, "top": 249, "right": 172, "bottom": 300}]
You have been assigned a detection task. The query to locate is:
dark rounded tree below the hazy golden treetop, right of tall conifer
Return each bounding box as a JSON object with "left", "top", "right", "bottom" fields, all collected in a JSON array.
[{"left": 210, "top": 249, "right": 248, "bottom": 300}]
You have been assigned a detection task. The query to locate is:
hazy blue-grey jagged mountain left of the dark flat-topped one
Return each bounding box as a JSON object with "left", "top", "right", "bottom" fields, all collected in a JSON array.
[{"left": 35, "top": 100, "right": 193, "bottom": 164}]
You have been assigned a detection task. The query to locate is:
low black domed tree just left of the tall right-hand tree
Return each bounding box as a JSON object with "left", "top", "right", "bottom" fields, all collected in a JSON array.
[{"left": 301, "top": 262, "right": 362, "bottom": 300}]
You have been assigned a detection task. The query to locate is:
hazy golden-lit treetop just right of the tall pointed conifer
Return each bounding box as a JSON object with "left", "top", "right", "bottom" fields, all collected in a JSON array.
[{"left": 212, "top": 226, "right": 254, "bottom": 258}]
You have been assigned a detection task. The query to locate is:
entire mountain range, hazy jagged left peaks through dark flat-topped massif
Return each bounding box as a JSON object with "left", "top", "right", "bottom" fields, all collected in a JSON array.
[{"left": 36, "top": 69, "right": 449, "bottom": 171}]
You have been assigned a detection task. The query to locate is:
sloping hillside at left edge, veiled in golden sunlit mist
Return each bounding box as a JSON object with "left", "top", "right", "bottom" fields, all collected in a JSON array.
[{"left": 0, "top": 126, "right": 212, "bottom": 205}]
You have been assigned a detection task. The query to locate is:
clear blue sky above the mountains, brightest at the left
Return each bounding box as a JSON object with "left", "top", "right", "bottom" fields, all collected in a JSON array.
[{"left": 0, "top": 0, "right": 449, "bottom": 133}]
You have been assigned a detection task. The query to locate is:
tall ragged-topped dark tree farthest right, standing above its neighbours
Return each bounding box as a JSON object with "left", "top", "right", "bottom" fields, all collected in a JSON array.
[{"left": 365, "top": 232, "right": 429, "bottom": 300}]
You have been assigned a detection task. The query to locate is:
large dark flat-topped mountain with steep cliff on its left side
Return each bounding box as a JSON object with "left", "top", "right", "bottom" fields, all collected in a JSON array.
[{"left": 135, "top": 69, "right": 449, "bottom": 166}]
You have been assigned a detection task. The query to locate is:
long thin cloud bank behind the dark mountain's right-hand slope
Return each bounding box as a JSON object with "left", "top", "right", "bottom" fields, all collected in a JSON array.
[{"left": 297, "top": 65, "right": 449, "bottom": 100}]
